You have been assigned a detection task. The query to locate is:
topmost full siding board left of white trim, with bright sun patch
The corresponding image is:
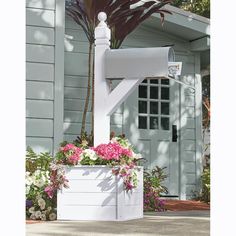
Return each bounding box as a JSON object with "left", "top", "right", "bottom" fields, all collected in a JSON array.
[{"left": 26, "top": 8, "right": 55, "bottom": 27}]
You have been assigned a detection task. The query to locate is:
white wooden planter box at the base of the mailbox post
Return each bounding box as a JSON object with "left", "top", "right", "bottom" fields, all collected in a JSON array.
[{"left": 57, "top": 166, "right": 143, "bottom": 221}]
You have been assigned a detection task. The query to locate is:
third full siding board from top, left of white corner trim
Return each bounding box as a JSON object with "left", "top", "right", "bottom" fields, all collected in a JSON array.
[{"left": 26, "top": 44, "right": 54, "bottom": 63}]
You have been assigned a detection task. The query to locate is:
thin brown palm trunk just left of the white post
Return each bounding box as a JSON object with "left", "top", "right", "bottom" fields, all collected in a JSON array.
[{"left": 80, "top": 43, "right": 94, "bottom": 136}]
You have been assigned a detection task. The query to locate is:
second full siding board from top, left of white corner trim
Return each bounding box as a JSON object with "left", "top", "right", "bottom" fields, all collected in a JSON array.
[{"left": 26, "top": 26, "right": 54, "bottom": 45}]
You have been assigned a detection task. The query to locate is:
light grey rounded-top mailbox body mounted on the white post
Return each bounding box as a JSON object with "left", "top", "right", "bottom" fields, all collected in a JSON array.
[{"left": 105, "top": 47, "right": 174, "bottom": 78}]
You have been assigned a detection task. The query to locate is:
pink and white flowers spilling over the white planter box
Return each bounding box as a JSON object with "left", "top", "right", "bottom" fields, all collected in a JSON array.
[{"left": 45, "top": 137, "right": 142, "bottom": 201}]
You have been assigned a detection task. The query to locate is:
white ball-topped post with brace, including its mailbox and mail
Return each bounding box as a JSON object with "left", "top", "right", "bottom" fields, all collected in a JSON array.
[{"left": 94, "top": 12, "right": 182, "bottom": 146}]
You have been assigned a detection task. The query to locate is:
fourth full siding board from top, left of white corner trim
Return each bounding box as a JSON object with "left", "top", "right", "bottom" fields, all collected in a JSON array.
[{"left": 26, "top": 62, "right": 54, "bottom": 82}]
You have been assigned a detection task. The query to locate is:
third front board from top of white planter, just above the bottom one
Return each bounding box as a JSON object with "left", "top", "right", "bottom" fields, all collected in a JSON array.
[{"left": 57, "top": 193, "right": 116, "bottom": 206}]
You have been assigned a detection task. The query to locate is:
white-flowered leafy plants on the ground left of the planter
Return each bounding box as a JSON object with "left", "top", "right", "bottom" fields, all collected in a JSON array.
[{"left": 25, "top": 148, "right": 56, "bottom": 220}]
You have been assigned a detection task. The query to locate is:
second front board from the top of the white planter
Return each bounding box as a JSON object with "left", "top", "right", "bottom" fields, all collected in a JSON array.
[{"left": 63, "top": 179, "right": 116, "bottom": 193}]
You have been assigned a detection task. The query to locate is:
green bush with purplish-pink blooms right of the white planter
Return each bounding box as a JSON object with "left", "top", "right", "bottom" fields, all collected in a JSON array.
[{"left": 144, "top": 166, "right": 168, "bottom": 211}]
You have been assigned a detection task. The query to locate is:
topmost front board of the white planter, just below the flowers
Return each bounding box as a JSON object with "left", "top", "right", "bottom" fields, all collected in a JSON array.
[{"left": 66, "top": 166, "right": 115, "bottom": 180}]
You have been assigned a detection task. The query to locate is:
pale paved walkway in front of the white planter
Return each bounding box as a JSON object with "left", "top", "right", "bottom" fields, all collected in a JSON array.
[{"left": 26, "top": 210, "right": 210, "bottom": 236}]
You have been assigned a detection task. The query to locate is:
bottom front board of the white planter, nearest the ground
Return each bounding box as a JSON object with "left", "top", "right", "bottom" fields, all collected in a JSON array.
[{"left": 57, "top": 205, "right": 116, "bottom": 221}]
